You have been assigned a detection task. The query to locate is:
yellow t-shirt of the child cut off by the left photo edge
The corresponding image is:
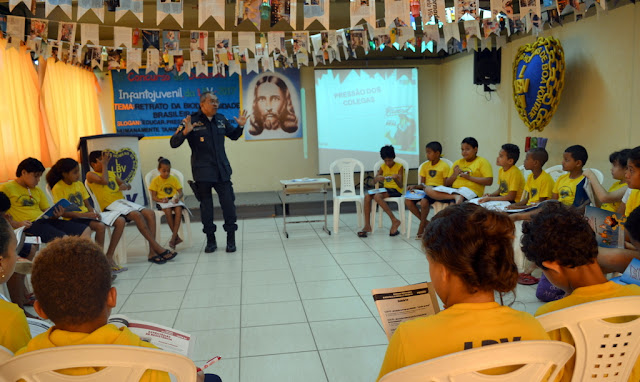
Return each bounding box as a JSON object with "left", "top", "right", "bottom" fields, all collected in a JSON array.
[{"left": 0, "top": 296, "right": 31, "bottom": 353}]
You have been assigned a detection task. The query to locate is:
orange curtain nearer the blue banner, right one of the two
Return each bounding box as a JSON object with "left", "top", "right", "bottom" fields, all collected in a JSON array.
[{"left": 42, "top": 58, "right": 102, "bottom": 160}]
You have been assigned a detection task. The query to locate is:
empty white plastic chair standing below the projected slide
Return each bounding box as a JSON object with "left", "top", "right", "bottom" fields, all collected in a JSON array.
[{"left": 329, "top": 158, "right": 364, "bottom": 233}]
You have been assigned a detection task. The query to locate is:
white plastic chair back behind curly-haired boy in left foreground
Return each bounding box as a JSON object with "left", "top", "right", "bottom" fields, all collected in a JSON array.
[{"left": 0, "top": 345, "right": 196, "bottom": 382}]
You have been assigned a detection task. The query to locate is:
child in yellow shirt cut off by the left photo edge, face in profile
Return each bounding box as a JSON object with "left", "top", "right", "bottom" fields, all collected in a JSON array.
[{"left": 0, "top": 217, "right": 31, "bottom": 353}]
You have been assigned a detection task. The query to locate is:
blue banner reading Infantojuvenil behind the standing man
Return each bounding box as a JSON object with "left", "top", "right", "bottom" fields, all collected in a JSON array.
[{"left": 111, "top": 69, "right": 240, "bottom": 137}]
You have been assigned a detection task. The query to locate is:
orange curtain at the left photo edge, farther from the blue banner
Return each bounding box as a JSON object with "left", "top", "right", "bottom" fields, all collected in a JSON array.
[{"left": 0, "top": 39, "right": 51, "bottom": 182}]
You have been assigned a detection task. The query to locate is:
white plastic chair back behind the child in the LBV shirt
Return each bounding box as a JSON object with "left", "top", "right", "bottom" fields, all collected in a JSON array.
[{"left": 380, "top": 341, "right": 574, "bottom": 382}]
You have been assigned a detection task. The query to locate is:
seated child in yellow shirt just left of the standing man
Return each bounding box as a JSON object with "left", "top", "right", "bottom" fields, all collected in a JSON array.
[{"left": 149, "top": 157, "right": 183, "bottom": 249}]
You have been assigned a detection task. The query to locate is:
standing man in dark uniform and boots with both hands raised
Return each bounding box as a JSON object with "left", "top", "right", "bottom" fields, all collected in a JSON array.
[{"left": 170, "top": 92, "right": 247, "bottom": 253}]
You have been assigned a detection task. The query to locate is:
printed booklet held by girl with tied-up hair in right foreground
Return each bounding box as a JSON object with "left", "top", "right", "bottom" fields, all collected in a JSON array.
[{"left": 371, "top": 283, "right": 440, "bottom": 340}]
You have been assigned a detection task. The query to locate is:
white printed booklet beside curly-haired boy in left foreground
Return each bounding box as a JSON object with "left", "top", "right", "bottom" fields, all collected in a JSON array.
[{"left": 107, "top": 314, "right": 195, "bottom": 357}]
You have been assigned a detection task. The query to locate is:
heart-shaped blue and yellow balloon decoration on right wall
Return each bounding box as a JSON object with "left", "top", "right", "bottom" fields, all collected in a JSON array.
[{"left": 513, "top": 37, "right": 565, "bottom": 131}]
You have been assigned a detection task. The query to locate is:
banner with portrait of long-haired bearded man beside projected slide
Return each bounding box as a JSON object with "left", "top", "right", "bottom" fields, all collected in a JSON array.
[{"left": 242, "top": 68, "right": 302, "bottom": 141}]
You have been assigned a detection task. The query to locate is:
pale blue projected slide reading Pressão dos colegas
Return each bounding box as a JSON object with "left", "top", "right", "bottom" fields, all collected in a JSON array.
[{"left": 315, "top": 68, "right": 419, "bottom": 174}]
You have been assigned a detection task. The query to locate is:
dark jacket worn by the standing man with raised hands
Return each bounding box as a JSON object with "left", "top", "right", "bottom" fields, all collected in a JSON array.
[{"left": 170, "top": 111, "right": 243, "bottom": 182}]
